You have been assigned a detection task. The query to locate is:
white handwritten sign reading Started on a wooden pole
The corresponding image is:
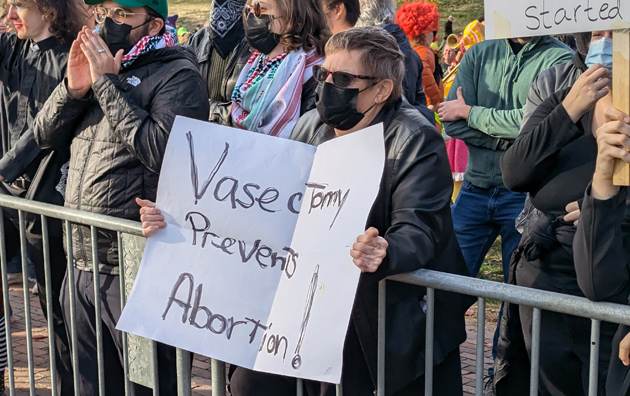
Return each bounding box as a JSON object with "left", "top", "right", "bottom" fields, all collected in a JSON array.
[{"left": 485, "top": 0, "right": 630, "bottom": 39}]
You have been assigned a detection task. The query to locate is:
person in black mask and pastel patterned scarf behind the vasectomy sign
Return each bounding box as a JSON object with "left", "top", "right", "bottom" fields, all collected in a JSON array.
[{"left": 231, "top": 0, "right": 330, "bottom": 138}]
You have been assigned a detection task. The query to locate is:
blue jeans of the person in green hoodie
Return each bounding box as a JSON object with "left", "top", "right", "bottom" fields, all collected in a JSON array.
[{"left": 451, "top": 180, "right": 526, "bottom": 375}]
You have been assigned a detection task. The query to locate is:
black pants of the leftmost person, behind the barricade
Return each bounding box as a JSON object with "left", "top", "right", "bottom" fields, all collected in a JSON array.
[{"left": 3, "top": 210, "right": 74, "bottom": 396}]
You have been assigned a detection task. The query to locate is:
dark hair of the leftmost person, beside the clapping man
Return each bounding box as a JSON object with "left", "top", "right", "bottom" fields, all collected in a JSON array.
[{"left": 2, "top": 0, "right": 88, "bottom": 43}]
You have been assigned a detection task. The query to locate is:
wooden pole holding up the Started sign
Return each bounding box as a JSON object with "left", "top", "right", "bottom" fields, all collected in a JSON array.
[{"left": 612, "top": 25, "right": 630, "bottom": 186}]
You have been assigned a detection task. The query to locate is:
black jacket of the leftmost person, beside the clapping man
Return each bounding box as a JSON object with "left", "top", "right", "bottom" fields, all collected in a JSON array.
[{"left": 0, "top": 34, "right": 70, "bottom": 235}]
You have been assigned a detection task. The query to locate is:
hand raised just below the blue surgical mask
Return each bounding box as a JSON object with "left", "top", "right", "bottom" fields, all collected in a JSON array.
[{"left": 562, "top": 64, "right": 610, "bottom": 123}]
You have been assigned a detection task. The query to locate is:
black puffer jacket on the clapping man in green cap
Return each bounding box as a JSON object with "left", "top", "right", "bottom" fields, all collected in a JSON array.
[{"left": 33, "top": 47, "right": 208, "bottom": 274}]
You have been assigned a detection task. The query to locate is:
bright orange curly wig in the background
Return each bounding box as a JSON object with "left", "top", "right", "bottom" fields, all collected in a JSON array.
[{"left": 396, "top": 1, "right": 440, "bottom": 40}]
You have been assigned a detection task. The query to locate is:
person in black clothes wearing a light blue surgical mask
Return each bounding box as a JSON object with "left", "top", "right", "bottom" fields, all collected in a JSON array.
[{"left": 502, "top": 31, "right": 627, "bottom": 395}]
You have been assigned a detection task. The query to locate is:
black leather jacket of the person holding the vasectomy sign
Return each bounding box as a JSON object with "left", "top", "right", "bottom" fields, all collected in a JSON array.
[{"left": 291, "top": 101, "right": 470, "bottom": 395}]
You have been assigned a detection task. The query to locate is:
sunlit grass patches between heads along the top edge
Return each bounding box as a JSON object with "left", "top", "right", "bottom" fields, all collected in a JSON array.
[{"left": 169, "top": 0, "right": 483, "bottom": 35}]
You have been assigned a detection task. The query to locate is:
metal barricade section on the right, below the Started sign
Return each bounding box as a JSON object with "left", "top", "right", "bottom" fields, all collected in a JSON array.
[{"left": 377, "top": 270, "right": 630, "bottom": 396}]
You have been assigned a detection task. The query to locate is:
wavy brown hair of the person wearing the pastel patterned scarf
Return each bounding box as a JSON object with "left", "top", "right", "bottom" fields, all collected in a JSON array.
[{"left": 247, "top": 0, "right": 330, "bottom": 56}]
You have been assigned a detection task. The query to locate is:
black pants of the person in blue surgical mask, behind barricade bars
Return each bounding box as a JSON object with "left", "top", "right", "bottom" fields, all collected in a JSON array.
[{"left": 519, "top": 306, "right": 616, "bottom": 396}]
